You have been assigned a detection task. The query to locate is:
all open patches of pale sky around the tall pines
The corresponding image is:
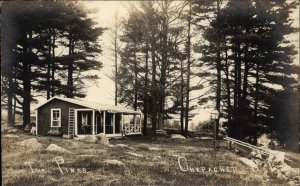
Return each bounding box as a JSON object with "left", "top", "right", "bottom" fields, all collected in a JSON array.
[{"left": 33, "top": 1, "right": 299, "bottom": 125}]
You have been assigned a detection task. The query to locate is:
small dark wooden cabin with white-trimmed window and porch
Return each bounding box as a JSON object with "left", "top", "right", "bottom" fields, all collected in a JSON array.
[{"left": 36, "top": 97, "right": 142, "bottom": 138}]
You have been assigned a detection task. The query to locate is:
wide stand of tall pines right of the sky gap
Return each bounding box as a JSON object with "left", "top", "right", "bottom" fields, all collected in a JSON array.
[{"left": 117, "top": 0, "right": 299, "bottom": 148}]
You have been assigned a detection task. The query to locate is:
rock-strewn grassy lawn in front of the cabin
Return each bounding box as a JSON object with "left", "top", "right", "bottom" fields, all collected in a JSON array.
[{"left": 1, "top": 134, "right": 286, "bottom": 186}]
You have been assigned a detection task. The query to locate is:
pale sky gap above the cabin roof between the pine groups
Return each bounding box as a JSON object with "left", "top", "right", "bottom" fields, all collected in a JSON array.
[{"left": 84, "top": 1, "right": 128, "bottom": 104}]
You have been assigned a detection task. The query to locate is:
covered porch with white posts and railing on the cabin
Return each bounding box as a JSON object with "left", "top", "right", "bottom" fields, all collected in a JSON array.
[{"left": 73, "top": 109, "right": 142, "bottom": 137}]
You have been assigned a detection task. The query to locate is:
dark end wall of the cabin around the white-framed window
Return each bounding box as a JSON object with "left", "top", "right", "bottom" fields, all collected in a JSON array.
[{"left": 37, "top": 99, "right": 85, "bottom": 135}]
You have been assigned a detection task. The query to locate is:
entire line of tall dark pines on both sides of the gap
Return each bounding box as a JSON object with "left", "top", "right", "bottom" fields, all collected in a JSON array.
[{"left": 1, "top": 0, "right": 299, "bottom": 148}]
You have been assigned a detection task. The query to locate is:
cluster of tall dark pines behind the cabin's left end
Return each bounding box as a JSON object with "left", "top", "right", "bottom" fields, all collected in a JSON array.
[{"left": 1, "top": 1, "right": 104, "bottom": 127}]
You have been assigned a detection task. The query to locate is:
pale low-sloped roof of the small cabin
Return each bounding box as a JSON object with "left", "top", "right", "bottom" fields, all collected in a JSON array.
[{"left": 36, "top": 96, "right": 142, "bottom": 114}]
